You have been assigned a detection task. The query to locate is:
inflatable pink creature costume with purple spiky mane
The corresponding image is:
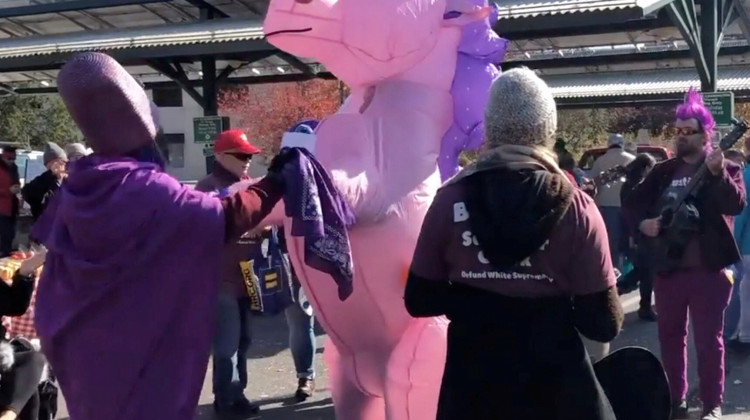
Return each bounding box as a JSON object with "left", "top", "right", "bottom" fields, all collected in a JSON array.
[{"left": 264, "top": 0, "right": 506, "bottom": 420}]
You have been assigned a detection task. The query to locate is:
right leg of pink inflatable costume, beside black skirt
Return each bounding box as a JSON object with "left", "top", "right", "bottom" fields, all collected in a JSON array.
[{"left": 385, "top": 318, "right": 448, "bottom": 420}]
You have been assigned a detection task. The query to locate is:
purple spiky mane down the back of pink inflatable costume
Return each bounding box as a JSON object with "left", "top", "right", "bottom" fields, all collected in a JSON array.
[{"left": 438, "top": 0, "right": 508, "bottom": 181}]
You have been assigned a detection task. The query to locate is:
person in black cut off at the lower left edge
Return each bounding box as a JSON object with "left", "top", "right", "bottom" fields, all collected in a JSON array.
[{"left": 0, "top": 251, "right": 46, "bottom": 420}]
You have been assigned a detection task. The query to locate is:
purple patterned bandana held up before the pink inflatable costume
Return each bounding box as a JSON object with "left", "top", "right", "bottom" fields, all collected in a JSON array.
[{"left": 282, "top": 147, "right": 354, "bottom": 301}]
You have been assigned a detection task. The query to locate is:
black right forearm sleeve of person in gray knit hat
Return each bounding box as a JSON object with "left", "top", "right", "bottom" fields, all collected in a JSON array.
[{"left": 573, "top": 286, "right": 624, "bottom": 343}]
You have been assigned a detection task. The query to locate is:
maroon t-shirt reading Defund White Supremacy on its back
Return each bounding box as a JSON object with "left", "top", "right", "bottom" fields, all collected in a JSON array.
[{"left": 411, "top": 184, "right": 615, "bottom": 297}]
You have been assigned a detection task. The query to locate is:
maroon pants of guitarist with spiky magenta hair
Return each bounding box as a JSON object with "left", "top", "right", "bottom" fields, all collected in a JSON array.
[{"left": 654, "top": 269, "right": 732, "bottom": 407}]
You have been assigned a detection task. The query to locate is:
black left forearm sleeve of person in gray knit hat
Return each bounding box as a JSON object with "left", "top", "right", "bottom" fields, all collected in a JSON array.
[{"left": 404, "top": 272, "right": 450, "bottom": 318}]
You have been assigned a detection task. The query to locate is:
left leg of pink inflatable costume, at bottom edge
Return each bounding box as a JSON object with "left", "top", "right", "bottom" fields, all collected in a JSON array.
[{"left": 323, "top": 340, "right": 388, "bottom": 420}]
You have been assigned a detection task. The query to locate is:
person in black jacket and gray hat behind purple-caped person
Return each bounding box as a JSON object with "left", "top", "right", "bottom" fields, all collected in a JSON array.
[{"left": 21, "top": 142, "right": 68, "bottom": 221}]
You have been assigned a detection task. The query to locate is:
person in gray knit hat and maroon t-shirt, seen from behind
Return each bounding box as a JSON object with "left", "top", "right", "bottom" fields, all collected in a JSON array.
[{"left": 404, "top": 68, "right": 623, "bottom": 420}]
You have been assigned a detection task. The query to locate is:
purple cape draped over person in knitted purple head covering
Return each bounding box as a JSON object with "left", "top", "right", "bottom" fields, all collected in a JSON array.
[{"left": 32, "top": 156, "right": 224, "bottom": 420}]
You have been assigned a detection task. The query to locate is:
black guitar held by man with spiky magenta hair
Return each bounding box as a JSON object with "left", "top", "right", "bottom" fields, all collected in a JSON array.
[{"left": 644, "top": 119, "right": 750, "bottom": 272}]
